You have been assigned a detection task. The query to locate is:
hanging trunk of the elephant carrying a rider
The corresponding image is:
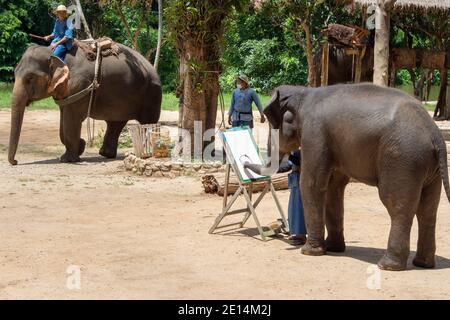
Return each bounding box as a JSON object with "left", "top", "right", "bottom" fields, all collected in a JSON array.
[{"left": 8, "top": 79, "right": 28, "bottom": 166}]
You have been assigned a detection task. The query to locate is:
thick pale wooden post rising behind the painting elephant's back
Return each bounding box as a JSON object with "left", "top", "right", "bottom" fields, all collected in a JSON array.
[{"left": 373, "top": 0, "right": 396, "bottom": 86}]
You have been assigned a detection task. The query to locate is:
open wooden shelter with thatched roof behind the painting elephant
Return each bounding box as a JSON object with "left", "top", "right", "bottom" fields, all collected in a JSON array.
[{"left": 320, "top": 0, "right": 450, "bottom": 119}]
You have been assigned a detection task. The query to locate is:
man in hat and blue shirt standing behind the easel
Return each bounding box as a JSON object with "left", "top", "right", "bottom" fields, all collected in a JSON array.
[{"left": 228, "top": 75, "right": 266, "bottom": 128}]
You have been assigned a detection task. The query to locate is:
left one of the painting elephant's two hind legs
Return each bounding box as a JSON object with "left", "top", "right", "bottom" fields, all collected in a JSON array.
[{"left": 378, "top": 174, "right": 422, "bottom": 271}]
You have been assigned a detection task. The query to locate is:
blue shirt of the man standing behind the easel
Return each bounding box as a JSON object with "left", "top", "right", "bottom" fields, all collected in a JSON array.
[{"left": 228, "top": 88, "right": 263, "bottom": 121}]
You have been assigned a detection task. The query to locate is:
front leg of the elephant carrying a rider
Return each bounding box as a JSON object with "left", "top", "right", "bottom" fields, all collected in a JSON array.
[{"left": 60, "top": 107, "right": 85, "bottom": 163}]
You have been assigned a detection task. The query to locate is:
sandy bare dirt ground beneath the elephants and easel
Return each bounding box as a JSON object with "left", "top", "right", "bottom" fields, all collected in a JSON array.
[{"left": 0, "top": 111, "right": 450, "bottom": 299}]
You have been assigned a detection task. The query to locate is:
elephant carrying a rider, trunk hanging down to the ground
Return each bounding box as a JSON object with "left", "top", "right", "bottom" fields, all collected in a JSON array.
[{"left": 8, "top": 44, "right": 162, "bottom": 165}]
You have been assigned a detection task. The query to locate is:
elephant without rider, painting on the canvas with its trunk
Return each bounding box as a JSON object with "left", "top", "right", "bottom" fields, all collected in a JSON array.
[{"left": 247, "top": 83, "right": 450, "bottom": 270}]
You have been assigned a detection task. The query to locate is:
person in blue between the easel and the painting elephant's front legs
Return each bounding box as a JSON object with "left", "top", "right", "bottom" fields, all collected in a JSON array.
[{"left": 278, "top": 150, "right": 307, "bottom": 245}]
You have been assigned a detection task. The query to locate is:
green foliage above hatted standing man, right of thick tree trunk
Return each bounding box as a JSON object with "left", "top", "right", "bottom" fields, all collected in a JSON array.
[{"left": 221, "top": 5, "right": 307, "bottom": 93}]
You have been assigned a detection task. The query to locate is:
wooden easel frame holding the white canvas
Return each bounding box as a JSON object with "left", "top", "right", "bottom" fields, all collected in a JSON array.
[{"left": 209, "top": 130, "right": 289, "bottom": 241}]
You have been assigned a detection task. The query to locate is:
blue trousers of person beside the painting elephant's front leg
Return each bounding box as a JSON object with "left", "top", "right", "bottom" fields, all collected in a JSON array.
[{"left": 288, "top": 172, "right": 307, "bottom": 236}]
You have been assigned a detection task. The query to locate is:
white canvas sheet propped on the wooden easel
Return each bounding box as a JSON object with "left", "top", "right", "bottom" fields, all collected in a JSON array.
[{"left": 222, "top": 129, "right": 265, "bottom": 181}]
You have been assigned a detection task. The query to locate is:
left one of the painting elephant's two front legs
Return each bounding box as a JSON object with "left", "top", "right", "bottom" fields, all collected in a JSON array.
[{"left": 300, "top": 148, "right": 331, "bottom": 256}]
